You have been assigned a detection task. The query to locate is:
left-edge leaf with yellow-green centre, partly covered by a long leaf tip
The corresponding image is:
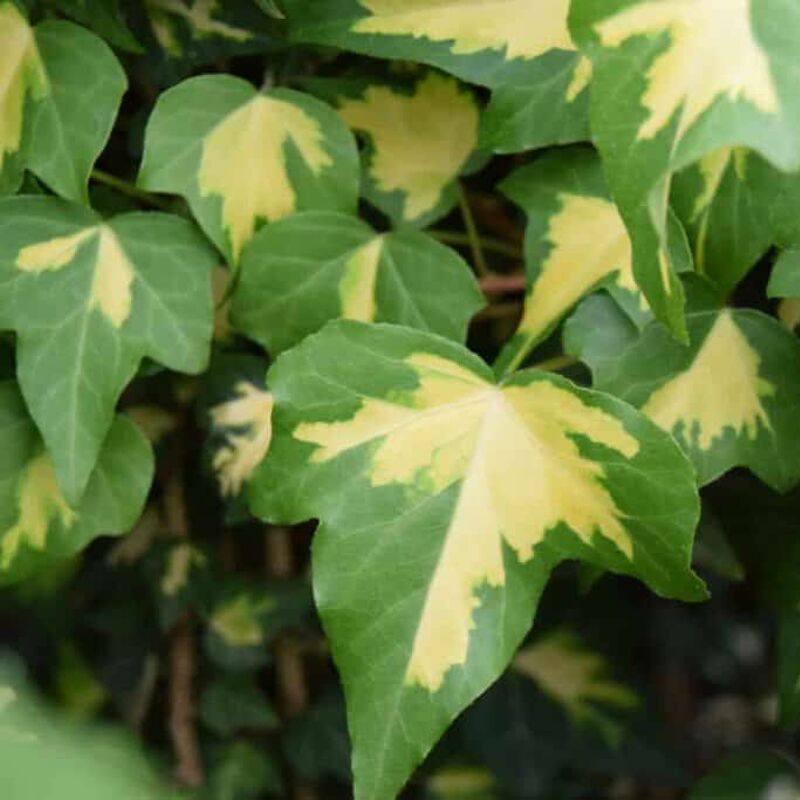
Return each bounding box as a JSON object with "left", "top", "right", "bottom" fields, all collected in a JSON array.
[{"left": 0, "top": 381, "right": 153, "bottom": 584}]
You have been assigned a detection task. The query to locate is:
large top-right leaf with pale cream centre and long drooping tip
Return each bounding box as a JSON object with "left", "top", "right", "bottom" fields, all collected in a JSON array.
[{"left": 570, "top": 0, "right": 800, "bottom": 341}]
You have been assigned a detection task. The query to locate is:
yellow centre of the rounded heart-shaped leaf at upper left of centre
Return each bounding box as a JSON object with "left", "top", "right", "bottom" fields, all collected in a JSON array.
[{"left": 198, "top": 95, "right": 333, "bottom": 260}]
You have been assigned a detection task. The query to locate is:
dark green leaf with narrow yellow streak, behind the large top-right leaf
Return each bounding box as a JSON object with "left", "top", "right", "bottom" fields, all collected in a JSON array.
[{"left": 672, "top": 147, "right": 775, "bottom": 296}]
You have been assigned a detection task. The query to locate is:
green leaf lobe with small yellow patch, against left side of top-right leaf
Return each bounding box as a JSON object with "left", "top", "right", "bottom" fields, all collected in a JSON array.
[{"left": 480, "top": 52, "right": 592, "bottom": 153}]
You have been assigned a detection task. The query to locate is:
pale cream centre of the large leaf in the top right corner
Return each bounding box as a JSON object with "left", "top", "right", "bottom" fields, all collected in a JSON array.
[{"left": 595, "top": 0, "right": 780, "bottom": 139}]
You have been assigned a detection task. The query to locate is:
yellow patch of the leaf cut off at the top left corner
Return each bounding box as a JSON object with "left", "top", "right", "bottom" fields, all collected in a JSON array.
[{"left": 0, "top": 3, "right": 48, "bottom": 170}]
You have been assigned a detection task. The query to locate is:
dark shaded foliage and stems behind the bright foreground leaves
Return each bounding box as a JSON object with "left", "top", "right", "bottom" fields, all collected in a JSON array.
[{"left": 0, "top": 0, "right": 800, "bottom": 800}]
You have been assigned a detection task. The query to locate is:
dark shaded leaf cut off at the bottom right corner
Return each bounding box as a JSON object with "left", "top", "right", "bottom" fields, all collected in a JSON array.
[{"left": 688, "top": 750, "right": 800, "bottom": 800}]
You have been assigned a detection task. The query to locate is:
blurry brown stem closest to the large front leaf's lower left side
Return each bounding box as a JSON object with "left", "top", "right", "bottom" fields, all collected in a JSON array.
[{"left": 265, "top": 526, "right": 317, "bottom": 800}]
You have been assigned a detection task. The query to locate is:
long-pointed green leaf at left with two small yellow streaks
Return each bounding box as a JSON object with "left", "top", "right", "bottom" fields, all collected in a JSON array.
[{"left": 0, "top": 197, "right": 216, "bottom": 503}]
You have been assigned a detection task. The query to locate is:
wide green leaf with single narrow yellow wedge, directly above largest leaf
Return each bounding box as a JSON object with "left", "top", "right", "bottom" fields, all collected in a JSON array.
[{"left": 231, "top": 211, "right": 484, "bottom": 354}]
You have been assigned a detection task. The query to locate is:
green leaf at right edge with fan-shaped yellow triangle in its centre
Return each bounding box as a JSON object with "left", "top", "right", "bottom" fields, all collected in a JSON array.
[{"left": 590, "top": 310, "right": 800, "bottom": 490}]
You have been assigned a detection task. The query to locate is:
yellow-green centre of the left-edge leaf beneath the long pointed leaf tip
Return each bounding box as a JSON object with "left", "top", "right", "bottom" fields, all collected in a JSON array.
[{"left": 0, "top": 453, "right": 77, "bottom": 569}]
